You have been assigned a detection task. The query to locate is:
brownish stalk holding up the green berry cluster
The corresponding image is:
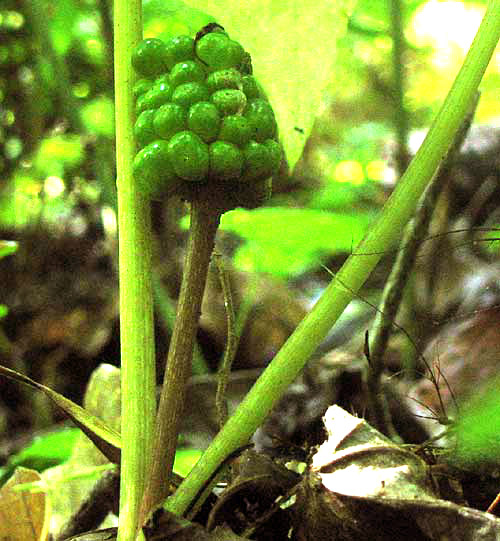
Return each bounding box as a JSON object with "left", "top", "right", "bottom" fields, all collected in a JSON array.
[{"left": 141, "top": 194, "right": 220, "bottom": 520}]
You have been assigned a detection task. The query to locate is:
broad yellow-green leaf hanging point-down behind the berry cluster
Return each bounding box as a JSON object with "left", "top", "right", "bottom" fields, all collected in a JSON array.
[{"left": 183, "top": 0, "right": 354, "bottom": 169}]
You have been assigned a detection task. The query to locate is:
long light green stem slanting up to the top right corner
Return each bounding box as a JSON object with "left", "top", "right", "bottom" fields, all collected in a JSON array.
[{"left": 167, "top": 0, "right": 500, "bottom": 515}]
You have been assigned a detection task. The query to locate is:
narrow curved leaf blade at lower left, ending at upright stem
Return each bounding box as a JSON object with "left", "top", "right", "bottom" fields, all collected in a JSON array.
[{"left": 0, "top": 366, "right": 121, "bottom": 464}]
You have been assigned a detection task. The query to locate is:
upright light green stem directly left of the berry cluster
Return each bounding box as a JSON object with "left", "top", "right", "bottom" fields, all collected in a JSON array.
[{"left": 114, "top": 0, "right": 156, "bottom": 541}]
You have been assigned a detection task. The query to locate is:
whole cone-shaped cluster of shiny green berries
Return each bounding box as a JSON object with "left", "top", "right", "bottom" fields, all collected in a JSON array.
[{"left": 132, "top": 24, "right": 282, "bottom": 204}]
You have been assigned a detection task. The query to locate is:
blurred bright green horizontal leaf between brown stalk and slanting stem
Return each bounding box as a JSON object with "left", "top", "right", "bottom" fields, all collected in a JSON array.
[{"left": 220, "top": 207, "right": 373, "bottom": 277}]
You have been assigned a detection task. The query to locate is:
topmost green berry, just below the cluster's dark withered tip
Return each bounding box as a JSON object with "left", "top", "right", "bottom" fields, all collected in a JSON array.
[{"left": 196, "top": 32, "right": 245, "bottom": 71}]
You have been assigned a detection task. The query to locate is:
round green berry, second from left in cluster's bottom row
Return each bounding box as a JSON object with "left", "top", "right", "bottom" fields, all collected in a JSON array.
[{"left": 168, "top": 131, "right": 209, "bottom": 181}]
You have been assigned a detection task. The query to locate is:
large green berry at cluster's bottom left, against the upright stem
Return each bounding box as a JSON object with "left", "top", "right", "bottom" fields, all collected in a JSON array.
[{"left": 133, "top": 141, "right": 179, "bottom": 197}]
